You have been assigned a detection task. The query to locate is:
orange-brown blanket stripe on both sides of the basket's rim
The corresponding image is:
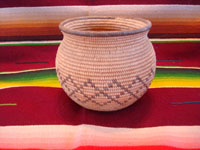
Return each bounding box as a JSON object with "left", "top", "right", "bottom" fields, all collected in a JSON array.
[{"left": 0, "top": 21, "right": 200, "bottom": 36}]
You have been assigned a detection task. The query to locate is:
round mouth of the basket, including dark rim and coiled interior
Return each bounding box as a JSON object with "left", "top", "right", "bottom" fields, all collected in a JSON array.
[{"left": 59, "top": 17, "right": 151, "bottom": 36}]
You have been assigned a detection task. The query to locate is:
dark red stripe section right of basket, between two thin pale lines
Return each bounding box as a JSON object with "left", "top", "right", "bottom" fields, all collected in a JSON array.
[{"left": 153, "top": 43, "right": 200, "bottom": 67}]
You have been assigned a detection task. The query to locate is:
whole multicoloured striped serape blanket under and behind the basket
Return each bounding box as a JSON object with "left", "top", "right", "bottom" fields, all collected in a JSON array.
[{"left": 0, "top": 0, "right": 200, "bottom": 150}]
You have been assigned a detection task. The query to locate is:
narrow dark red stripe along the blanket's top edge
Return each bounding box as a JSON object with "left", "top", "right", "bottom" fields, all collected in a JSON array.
[{"left": 0, "top": 0, "right": 200, "bottom": 8}]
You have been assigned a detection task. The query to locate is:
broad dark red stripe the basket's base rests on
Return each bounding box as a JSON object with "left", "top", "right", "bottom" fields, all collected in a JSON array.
[{"left": 0, "top": 87, "right": 200, "bottom": 128}]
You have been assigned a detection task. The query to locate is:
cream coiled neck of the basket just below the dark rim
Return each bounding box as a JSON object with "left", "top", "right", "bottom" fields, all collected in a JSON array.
[{"left": 63, "top": 31, "right": 149, "bottom": 51}]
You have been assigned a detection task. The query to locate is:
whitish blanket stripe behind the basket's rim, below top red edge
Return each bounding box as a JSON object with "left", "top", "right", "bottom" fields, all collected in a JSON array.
[{"left": 0, "top": 5, "right": 200, "bottom": 24}]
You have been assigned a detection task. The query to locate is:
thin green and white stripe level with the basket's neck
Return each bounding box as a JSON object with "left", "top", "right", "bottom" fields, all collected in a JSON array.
[{"left": 0, "top": 40, "right": 200, "bottom": 46}]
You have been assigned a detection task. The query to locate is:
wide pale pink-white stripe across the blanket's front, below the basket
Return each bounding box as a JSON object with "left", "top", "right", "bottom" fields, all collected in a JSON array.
[{"left": 0, "top": 125, "right": 200, "bottom": 149}]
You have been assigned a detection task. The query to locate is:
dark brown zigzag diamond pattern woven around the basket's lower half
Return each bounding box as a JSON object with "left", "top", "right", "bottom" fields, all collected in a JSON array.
[{"left": 56, "top": 69, "right": 154, "bottom": 106}]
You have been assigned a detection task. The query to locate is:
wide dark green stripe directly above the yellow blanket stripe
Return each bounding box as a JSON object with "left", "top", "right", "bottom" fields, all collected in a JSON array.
[{"left": 0, "top": 68, "right": 200, "bottom": 82}]
